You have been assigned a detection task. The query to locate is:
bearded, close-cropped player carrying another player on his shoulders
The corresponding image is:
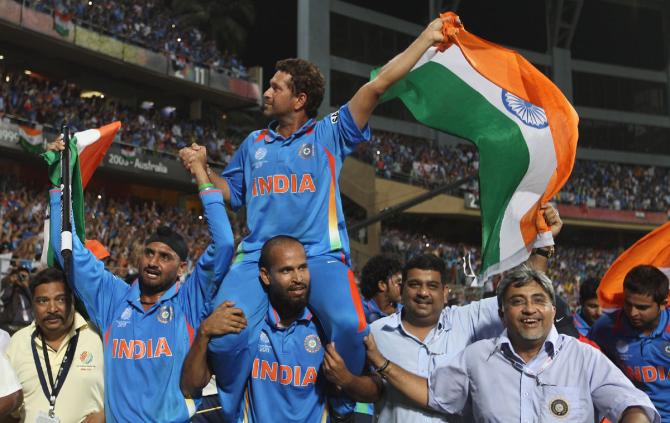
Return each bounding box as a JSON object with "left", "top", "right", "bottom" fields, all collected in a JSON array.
[{"left": 181, "top": 235, "right": 378, "bottom": 422}]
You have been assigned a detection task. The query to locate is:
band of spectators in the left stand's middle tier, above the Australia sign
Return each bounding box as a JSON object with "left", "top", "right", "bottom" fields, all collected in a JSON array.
[{"left": 0, "top": 73, "right": 242, "bottom": 164}]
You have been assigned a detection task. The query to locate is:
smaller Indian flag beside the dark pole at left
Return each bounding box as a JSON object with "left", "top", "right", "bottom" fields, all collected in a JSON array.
[{"left": 42, "top": 121, "right": 121, "bottom": 266}]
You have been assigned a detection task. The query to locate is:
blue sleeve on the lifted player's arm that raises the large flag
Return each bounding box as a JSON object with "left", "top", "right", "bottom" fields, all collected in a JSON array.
[{"left": 317, "top": 104, "right": 371, "bottom": 160}]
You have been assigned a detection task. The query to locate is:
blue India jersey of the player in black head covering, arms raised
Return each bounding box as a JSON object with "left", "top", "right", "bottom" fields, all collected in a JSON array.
[{"left": 50, "top": 190, "right": 234, "bottom": 423}]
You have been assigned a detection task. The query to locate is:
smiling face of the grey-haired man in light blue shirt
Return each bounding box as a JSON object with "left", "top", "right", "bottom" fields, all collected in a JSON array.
[{"left": 501, "top": 280, "right": 556, "bottom": 348}]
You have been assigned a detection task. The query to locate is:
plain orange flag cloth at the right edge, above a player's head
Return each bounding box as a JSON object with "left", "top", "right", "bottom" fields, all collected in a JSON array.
[{"left": 598, "top": 222, "right": 670, "bottom": 309}]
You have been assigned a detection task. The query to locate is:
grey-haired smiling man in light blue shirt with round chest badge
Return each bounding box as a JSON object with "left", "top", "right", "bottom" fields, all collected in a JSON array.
[{"left": 366, "top": 266, "right": 661, "bottom": 423}]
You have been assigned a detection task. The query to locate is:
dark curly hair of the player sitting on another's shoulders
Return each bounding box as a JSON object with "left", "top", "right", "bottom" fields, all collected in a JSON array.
[{"left": 275, "top": 59, "right": 326, "bottom": 118}]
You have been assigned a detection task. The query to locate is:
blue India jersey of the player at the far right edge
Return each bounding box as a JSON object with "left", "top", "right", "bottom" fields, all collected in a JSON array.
[{"left": 589, "top": 308, "right": 670, "bottom": 422}]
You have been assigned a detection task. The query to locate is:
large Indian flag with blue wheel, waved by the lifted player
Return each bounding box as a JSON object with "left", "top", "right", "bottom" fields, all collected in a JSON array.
[{"left": 382, "top": 12, "right": 578, "bottom": 279}]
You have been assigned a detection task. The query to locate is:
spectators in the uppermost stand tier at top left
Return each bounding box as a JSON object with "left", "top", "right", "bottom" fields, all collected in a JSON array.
[{"left": 19, "top": 0, "right": 248, "bottom": 79}]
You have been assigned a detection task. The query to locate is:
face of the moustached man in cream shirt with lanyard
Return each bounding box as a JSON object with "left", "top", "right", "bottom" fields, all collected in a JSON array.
[{"left": 33, "top": 281, "right": 74, "bottom": 339}]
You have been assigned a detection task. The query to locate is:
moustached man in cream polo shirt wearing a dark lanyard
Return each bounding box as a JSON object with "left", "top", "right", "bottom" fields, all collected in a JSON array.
[{"left": 7, "top": 268, "right": 104, "bottom": 422}]
